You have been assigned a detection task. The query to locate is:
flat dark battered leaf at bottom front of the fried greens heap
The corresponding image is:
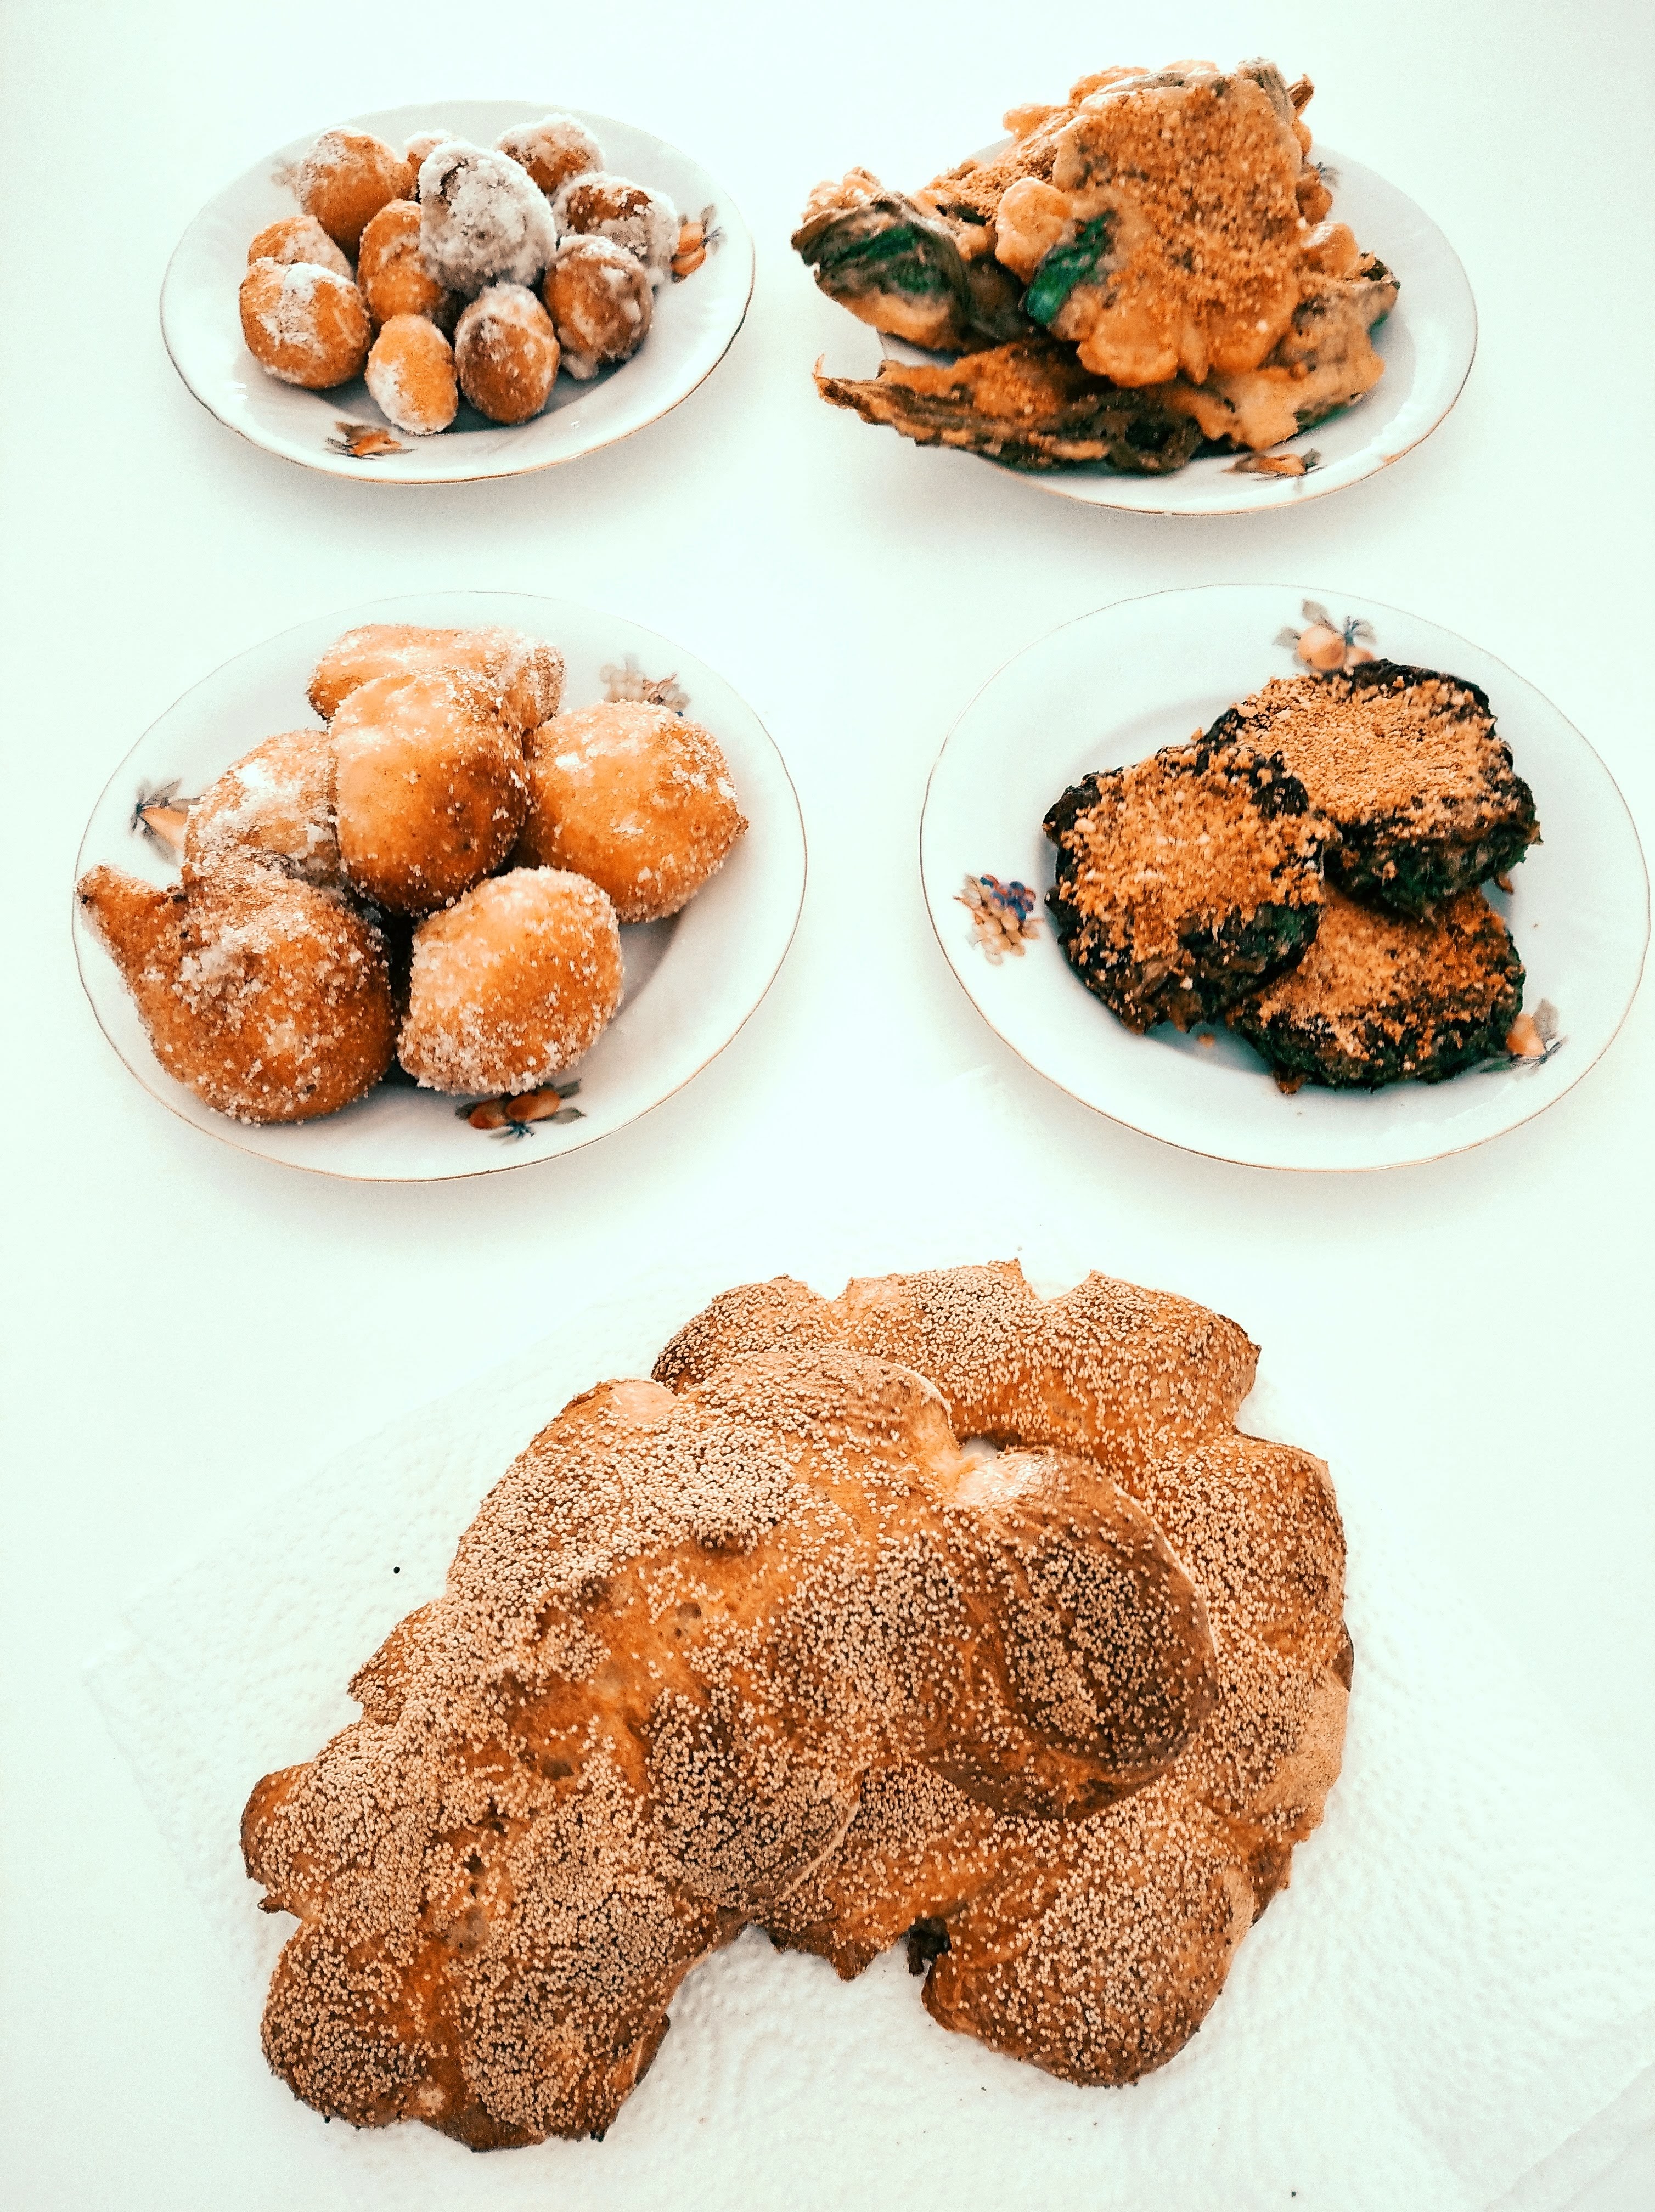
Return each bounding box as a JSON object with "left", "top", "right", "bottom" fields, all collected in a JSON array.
[{"left": 817, "top": 338, "right": 1201, "bottom": 476}]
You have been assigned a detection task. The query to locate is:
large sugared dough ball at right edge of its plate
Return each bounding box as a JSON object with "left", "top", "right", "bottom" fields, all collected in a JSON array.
[{"left": 513, "top": 701, "right": 748, "bottom": 922}]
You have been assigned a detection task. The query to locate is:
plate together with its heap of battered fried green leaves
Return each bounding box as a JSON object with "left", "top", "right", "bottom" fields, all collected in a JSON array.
[{"left": 792, "top": 60, "right": 1476, "bottom": 513}]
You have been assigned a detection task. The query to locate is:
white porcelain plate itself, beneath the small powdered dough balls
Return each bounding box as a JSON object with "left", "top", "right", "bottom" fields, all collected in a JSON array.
[{"left": 161, "top": 99, "right": 752, "bottom": 484}]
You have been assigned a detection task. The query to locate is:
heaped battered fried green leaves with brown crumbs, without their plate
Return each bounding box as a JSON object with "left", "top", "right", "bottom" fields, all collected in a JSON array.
[{"left": 792, "top": 62, "right": 1396, "bottom": 476}]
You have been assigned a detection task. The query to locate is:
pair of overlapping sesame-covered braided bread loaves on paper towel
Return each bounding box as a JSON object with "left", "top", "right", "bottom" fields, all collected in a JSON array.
[{"left": 244, "top": 1263, "right": 1352, "bottom": 2148}]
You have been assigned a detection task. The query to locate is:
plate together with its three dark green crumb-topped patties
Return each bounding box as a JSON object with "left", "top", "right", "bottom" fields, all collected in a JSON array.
[{"left": 920, "top": 584, "right": 1648, "bottom": 1168}]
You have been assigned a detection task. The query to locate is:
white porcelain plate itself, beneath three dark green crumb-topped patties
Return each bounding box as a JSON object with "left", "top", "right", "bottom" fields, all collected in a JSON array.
[{"left": 920, "top": 584, "right": 1648, "bottom": 1168}]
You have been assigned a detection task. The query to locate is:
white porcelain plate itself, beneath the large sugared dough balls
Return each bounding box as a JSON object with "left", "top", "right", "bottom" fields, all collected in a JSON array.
[{"left": 75, "top": 591, "right": 806, "bottom": 1183}]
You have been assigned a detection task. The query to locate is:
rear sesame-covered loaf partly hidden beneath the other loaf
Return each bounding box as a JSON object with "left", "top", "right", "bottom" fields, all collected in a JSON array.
[{"left": 657, "top": 1265, "right": 1352, "bottom": 2084}]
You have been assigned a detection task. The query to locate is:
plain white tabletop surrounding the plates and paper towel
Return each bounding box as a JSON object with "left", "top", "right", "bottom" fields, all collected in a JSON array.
[{"left": 0, "top": 0, "right": 1655, "bottom": 2212}]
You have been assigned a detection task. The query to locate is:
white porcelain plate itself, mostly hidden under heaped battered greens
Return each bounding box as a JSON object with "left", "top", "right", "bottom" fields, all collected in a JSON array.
[{"left": 881, "top": 142, "right": 1476, "bottom": 515}]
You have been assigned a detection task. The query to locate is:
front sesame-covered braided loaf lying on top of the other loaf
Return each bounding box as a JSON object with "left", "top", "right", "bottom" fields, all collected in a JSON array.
[{"left": 244, "top": 1347, "right": 1215, "bottom": 2148}]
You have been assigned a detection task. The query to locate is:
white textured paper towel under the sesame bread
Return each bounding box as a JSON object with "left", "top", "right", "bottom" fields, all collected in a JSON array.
[{"left": 93, "top": 1075, "right": 1655, "bottom": 2212}]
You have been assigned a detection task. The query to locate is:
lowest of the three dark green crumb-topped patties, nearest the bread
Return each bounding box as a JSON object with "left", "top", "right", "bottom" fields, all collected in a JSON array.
[{"left": 1230, "top": 891, "right": 1522, "bottom": 1091}]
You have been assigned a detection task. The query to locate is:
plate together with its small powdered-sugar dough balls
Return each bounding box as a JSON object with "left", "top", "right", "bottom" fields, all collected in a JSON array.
[{"left": 161, "top": 99, "right": 752, "bottom": 484}]
